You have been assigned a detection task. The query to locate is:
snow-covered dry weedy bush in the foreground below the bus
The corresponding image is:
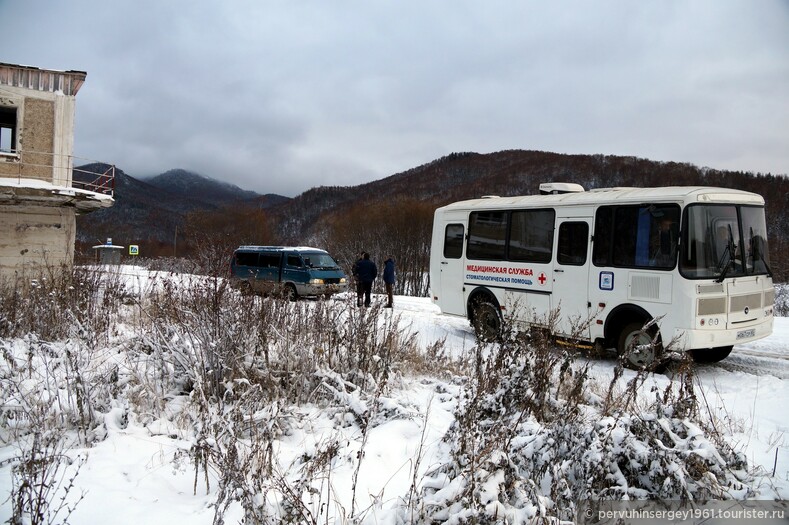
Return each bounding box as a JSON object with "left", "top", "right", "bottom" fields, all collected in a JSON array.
[{"left": 420, "top": 334, "right": 748, "bottom": 523}]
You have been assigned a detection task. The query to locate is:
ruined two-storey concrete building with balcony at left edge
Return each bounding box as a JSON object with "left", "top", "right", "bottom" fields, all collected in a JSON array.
[{"left": 0, "top": 63, "right": 115, "bottom": 280}]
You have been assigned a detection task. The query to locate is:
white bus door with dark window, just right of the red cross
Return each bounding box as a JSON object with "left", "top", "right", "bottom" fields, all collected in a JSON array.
[{"left": 551, "top": 217, "right": 594, "bottom": 340}]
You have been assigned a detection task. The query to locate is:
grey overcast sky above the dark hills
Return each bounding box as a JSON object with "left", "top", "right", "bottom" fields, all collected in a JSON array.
[{"left": 0, "top": 0, "right": 789, "bottom": 197}]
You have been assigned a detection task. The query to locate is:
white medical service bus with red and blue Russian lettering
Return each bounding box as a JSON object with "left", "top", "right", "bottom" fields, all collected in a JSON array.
[{"left": 430, "top": 183, "right": 775, "bottom": 366}]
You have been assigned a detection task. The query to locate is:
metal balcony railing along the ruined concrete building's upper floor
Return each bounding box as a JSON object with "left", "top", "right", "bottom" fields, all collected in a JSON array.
[{"left": 0, "top": 150, "right": 115, "bottom": 196}]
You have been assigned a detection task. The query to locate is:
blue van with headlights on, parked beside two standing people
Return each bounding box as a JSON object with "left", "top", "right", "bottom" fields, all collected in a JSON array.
[{"left": 230, "top": 246, "right": 348, "bottom": 300}]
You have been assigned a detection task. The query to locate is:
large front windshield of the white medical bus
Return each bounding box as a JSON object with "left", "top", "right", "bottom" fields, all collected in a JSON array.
[{"left": 679, "top": 204, "right": 772, "bottom": 281}]
